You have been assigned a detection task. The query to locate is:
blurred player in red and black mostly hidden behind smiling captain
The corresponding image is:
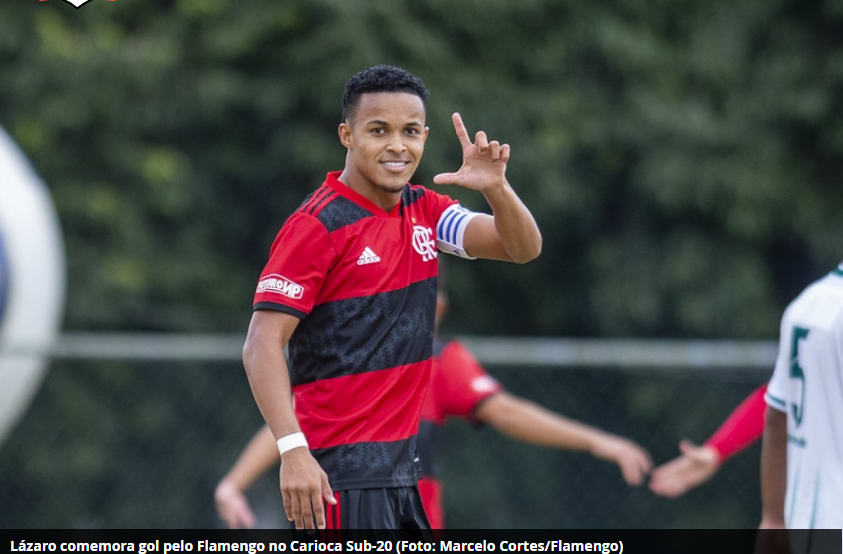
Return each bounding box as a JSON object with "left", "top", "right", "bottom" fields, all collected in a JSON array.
[{"left": 214, "top": 289, "right": 652, "bottom": 529}]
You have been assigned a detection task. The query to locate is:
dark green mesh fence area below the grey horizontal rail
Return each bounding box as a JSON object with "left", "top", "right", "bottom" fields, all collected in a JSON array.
[{"left": 0, "top": 344, "right": 768, "bottom": 528}]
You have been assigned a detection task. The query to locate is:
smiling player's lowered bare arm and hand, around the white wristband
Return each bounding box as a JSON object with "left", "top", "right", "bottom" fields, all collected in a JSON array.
[{"left": 243, "top": 310, "right": 336, "bottom": 529}]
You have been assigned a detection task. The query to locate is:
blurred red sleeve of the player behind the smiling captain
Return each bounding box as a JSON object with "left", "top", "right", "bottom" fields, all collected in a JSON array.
[{"left": 437, "top": 341, "right": 501, "bottom": 419}]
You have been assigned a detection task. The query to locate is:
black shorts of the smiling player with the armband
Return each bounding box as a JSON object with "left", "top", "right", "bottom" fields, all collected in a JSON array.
[{"left": 324, "top": 487, "right": 430, "bottom": 529}]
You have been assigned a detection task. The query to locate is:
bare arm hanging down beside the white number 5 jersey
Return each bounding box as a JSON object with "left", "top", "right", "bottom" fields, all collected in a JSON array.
[{"left": 760, "top": 406, "right": 787, "bottom": 529}]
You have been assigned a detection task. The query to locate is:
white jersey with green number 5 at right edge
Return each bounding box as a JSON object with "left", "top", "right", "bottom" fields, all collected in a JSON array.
[{"left": 765, "top": 264, "right": 843, "bottom": 529}]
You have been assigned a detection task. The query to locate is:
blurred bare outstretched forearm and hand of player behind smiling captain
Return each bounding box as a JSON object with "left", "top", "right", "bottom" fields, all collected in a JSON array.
[{"left": 474, "top": 391, "right": 653, "bottom": 485}]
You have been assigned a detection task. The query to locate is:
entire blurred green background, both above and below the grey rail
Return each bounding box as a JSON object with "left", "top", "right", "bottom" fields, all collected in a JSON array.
[{"left": 0, "top": 0, "right": 843, "bottom": 527}]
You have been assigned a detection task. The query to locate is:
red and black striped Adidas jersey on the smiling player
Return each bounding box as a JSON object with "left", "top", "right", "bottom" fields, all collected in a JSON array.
[{"left": 254, "top": 171, "right": 456, "bottom": 490}]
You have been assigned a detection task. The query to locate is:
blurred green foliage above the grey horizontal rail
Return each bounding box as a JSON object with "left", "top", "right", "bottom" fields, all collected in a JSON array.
[{"left": 0, "top": 0, "right": 843, "bottom": 337}]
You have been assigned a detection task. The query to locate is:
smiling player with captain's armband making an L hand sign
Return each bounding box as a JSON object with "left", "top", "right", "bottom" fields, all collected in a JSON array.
[{"left": 243, "top": 62, "right": 541, "bottom": 529}]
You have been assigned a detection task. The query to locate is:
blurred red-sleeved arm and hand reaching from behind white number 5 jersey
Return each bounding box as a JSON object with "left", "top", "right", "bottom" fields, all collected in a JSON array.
[{"left": 650, "top": 384, "right": 767, "bottom": 498}]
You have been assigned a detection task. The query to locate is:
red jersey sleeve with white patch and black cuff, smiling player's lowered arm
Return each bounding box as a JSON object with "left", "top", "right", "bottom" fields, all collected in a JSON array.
[{"left": 253, "top": 213, "right": 334, "bottom": 319}]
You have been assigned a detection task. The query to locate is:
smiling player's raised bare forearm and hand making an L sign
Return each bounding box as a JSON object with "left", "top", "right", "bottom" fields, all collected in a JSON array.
[{"left": 433, "top": 113, "right": 542, "bottom": 263}]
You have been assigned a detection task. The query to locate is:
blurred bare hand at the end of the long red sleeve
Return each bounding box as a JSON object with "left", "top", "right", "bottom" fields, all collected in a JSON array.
[{"left": 650, "top": 439, "right": 720, "bottom": 498}]
